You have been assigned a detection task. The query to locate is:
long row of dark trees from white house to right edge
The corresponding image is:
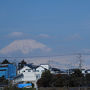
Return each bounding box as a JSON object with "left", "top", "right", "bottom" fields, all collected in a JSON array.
[{"left": 37, "top": 69, "right": 90, "bottom": 87}]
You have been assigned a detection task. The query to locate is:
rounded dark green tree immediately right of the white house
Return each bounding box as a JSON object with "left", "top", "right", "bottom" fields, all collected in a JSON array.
[{"left": 37, "top": 70, "right": 52, "bottom": 87}]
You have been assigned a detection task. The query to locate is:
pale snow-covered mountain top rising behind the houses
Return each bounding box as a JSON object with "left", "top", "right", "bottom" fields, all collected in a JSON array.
[{"left": 0, "top": 39, "right": 51, "bottom": 54}]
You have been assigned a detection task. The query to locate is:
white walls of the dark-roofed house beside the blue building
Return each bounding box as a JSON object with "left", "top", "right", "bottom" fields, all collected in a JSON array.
[{"left": 14, "top": 65, "right": 50, "bottom": 83}]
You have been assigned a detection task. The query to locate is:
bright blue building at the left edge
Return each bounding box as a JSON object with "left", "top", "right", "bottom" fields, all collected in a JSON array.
[{"left": 0, "top": 63, "right": 16, "bottom": 80}]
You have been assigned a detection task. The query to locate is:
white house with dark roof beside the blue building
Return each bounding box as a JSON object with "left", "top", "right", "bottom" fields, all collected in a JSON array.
[{"left": 13, "top": 64, "right": 50, "bottom": 87}]
